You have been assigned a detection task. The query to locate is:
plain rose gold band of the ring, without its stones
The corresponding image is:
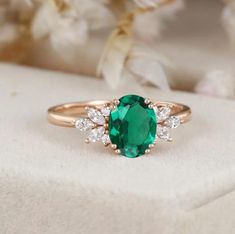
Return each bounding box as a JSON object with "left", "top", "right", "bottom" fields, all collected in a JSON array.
[{"left": 48, "top": 100, "right": 191, "bottom": 127}]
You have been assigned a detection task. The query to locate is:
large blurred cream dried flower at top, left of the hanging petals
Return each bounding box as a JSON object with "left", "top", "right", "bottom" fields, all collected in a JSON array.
[{"left": 32, "top": 0, "right": 115, "bottom": 61}]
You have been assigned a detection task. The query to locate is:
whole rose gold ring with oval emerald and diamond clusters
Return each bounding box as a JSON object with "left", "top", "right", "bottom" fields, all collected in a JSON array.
[{"left": 48, "top": 95, "right": 191, "bottom": 158}]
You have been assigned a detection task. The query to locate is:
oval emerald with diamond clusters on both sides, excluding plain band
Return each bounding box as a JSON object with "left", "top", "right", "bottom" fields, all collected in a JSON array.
[{"left": 74, "top": 95, "right": 182, "bottom": 158}]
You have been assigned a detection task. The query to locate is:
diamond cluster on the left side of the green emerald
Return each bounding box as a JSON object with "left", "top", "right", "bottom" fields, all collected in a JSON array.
[{"left": 75, "top": 103, "right": 111, "bottom": 145}]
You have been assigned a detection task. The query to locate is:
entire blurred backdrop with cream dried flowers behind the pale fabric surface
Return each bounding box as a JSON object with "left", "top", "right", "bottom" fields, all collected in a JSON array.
[{"left": 0, "top": 0, "right": 235, "bottom": 99}]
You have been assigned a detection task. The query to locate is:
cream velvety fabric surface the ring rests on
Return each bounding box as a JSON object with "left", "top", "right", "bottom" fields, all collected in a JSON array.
[{"left": 0, "top": 64, "right": 235, "bottom": 234}]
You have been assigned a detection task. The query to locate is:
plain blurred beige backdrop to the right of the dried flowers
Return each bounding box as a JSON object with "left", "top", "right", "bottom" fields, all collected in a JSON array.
[{"left": 156, "top": 0, "right": 235, "bottom": 90}]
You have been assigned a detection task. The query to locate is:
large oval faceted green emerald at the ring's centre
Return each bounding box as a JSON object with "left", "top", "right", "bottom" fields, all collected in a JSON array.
[{"left": 109, "top": 95, "right": 157, "bottom": 158}]
